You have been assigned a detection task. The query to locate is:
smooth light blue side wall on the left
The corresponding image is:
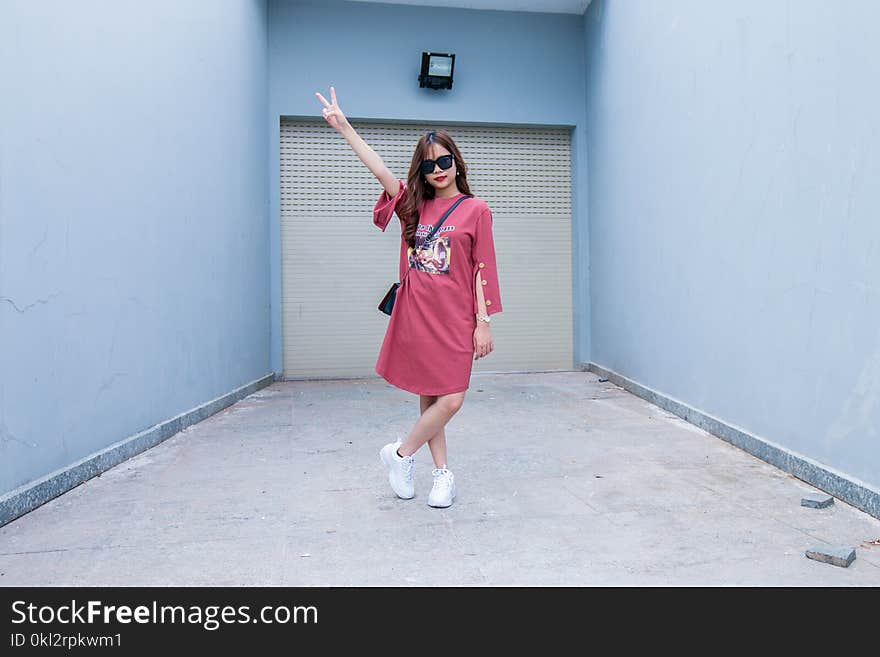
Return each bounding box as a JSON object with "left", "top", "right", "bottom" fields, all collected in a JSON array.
[{"left": 0, "top": 0, "right": 271, "bottom": 494}]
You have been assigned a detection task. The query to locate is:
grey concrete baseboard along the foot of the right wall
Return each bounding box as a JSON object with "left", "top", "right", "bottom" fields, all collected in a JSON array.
[{"left": 579, "top": 362, "right": 880, "bottom": 518}]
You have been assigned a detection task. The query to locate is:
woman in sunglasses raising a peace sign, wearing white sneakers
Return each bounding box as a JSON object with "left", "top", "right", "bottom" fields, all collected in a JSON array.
[{"left": 315, "top": 87, "right": 502, "bottom": 507}]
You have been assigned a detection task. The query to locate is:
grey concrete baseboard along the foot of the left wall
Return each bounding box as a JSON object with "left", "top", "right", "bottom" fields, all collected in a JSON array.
[{"left": 0, "top": 373, "right": 275, "bottom": 527}]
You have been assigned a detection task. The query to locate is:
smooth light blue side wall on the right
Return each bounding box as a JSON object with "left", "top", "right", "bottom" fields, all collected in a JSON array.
[{"left": 585, "top": 0, "right": 880, "bottom": 487}]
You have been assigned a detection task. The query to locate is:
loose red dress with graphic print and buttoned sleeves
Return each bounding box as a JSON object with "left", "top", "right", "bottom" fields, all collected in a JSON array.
[{"left": 373, "top": 180, "right": 502, "bottom": 395}]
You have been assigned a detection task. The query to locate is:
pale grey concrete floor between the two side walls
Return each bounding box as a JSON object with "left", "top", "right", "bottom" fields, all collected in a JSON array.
[{"left": 0, "top": 372, "right": 880, "bottom": 586}]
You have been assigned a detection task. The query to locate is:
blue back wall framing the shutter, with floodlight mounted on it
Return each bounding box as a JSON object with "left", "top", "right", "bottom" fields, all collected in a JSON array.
[{"left": 269, "top": 0, "right": 589, "bottom": 373}]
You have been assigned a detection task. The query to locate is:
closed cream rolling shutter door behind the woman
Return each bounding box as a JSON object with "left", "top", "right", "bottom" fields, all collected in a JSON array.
[{"left": 280, "top": 120, "right": 573, "bottom": 379}]
